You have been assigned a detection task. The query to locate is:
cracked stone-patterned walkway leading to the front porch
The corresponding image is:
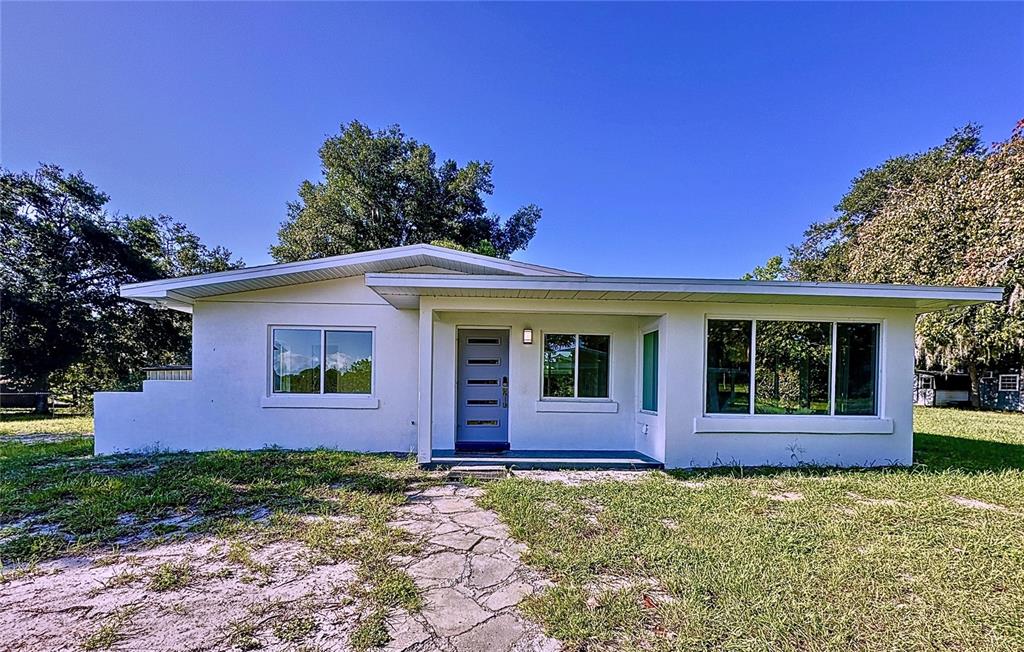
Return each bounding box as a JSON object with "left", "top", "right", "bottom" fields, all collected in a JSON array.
[{"left": 386, "top": 484, "right": 561, "bottom": 652}]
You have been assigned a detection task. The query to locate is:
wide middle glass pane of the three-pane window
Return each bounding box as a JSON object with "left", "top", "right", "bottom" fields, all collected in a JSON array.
[{"left": 754, "top": 320, "right": 831, "bottom": 415}]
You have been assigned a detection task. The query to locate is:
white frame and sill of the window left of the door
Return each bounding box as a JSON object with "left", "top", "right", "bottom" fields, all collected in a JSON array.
[{"left": 268, "top": 323, "right": 379, "bottom": 399}]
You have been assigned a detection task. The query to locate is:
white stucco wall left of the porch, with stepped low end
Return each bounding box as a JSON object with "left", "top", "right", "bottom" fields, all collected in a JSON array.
[{"left": 95, "top": 277, "right": 419, "bottom": 453}]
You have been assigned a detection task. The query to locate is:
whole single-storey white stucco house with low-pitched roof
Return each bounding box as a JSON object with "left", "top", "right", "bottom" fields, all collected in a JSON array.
[{"left": 95, "top": 245, "right": 1001, "bottom": 468}]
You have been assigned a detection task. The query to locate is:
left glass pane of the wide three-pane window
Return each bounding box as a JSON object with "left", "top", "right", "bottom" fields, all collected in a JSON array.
[{"left": 705, "top": 319, "right": 751, "bottom": 415}]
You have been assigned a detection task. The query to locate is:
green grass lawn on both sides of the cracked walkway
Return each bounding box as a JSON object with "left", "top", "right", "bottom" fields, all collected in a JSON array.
[{"left": 0, "top": 408, "right": 1024, "bottom": 651}]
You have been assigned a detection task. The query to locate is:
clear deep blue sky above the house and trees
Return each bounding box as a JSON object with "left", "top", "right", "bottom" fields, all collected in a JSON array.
[{"left": 0, "top": 1, "right": 1024, "bottom": 277}]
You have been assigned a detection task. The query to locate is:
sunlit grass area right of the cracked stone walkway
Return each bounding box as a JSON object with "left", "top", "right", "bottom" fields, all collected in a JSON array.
[{"left": 482, "top": 410, "right": 1024, "bottom": 651}]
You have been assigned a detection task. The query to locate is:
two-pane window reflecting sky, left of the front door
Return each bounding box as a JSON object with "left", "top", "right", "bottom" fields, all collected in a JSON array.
[{"left": 271, "top": 329, "right": 373, "bottom": 394}]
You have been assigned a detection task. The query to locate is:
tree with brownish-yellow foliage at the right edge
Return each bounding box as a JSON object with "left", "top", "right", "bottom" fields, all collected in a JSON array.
[{"left": 849, "top": 121, "right": 1024, "bottom": 406}]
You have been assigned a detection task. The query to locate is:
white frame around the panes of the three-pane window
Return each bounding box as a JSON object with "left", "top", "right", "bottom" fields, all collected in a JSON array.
[{"left": 700, "top": 313, "right": 886, "bottom": 419}]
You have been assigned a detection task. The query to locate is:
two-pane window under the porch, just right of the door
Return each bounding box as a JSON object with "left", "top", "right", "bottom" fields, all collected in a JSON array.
[{"left": 543, "top": 333, "right": 611, "bottom": 398}]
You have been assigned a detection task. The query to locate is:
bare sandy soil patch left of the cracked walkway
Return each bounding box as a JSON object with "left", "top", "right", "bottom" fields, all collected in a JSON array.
[{"left": 0, "top": 537, "right": 356, "bottom": 651}]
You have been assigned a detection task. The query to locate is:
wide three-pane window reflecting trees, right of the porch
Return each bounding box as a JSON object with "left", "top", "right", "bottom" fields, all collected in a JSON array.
[{"left": 705, "top": 319, "right": 879, "bottom": 416}]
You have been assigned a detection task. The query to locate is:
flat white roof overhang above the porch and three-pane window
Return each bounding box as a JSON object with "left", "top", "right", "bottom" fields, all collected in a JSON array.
[{"left": 366, "top": 273, "right": 1002, "bottom": 312}]
